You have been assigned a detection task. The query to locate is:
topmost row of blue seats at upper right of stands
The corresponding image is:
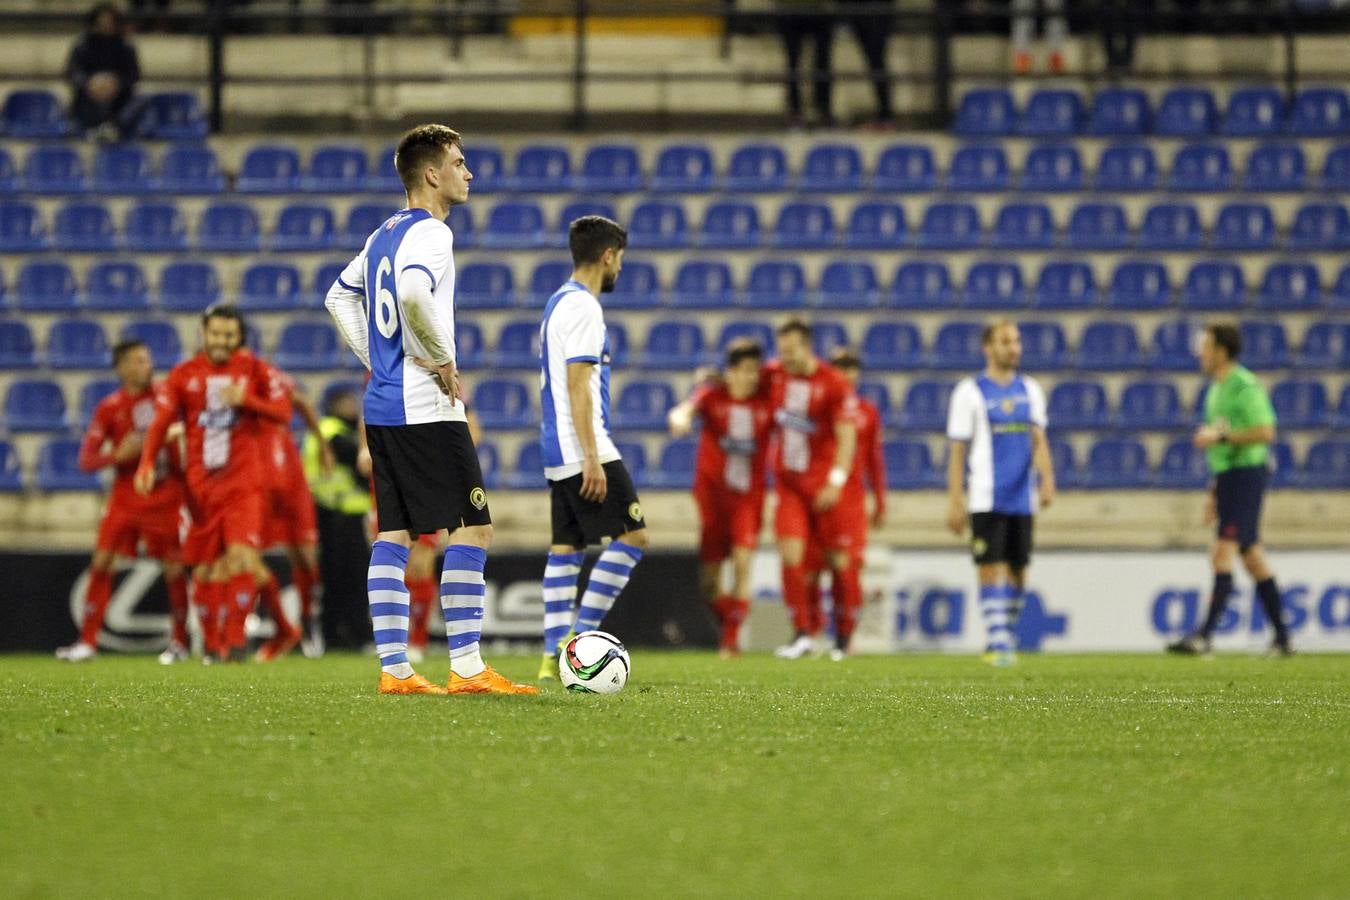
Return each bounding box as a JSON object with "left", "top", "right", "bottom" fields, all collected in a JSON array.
[{"left": 954, "top": 85, "right": 1350, "bottom": 138}]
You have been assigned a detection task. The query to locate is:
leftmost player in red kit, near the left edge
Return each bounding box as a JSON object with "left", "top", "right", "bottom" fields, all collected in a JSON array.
[{"left": 57, "top": 340, "right": 188, "bottom": 664}]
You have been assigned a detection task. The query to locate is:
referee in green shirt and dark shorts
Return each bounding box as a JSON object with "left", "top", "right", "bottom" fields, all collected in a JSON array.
[{"left": 1168, "top": 324, "right": 1291, "bottom": 656}]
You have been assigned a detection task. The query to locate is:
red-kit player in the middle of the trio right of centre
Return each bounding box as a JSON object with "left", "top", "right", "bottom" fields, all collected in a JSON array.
[{"left": 765, "top": 318, "right": 863, "bottom": 660}]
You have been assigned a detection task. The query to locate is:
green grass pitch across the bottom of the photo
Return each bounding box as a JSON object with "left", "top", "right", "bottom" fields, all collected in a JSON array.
[{"left": 0, "top": 650, "right": 1350, "bottom": 900}]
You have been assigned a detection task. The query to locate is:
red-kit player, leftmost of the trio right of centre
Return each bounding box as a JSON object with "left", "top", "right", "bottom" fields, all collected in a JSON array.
[{"left": 668, "top": 340, "right": 774, "bottom": 657}]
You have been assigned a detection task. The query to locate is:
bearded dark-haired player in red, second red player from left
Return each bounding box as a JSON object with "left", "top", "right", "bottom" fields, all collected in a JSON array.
[{"left": 135, "top": 305, "right": 285, "bottom": 658}]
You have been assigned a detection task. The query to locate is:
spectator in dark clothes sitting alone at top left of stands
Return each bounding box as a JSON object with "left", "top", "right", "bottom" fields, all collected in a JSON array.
[{"left": 66, "top": 3, "right": 140, "bottom": 139}]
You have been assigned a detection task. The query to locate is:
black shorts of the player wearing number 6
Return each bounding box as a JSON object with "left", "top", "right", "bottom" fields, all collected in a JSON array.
[{"left": 366, "top": 422, "right": 493, "bottom": 534}]
